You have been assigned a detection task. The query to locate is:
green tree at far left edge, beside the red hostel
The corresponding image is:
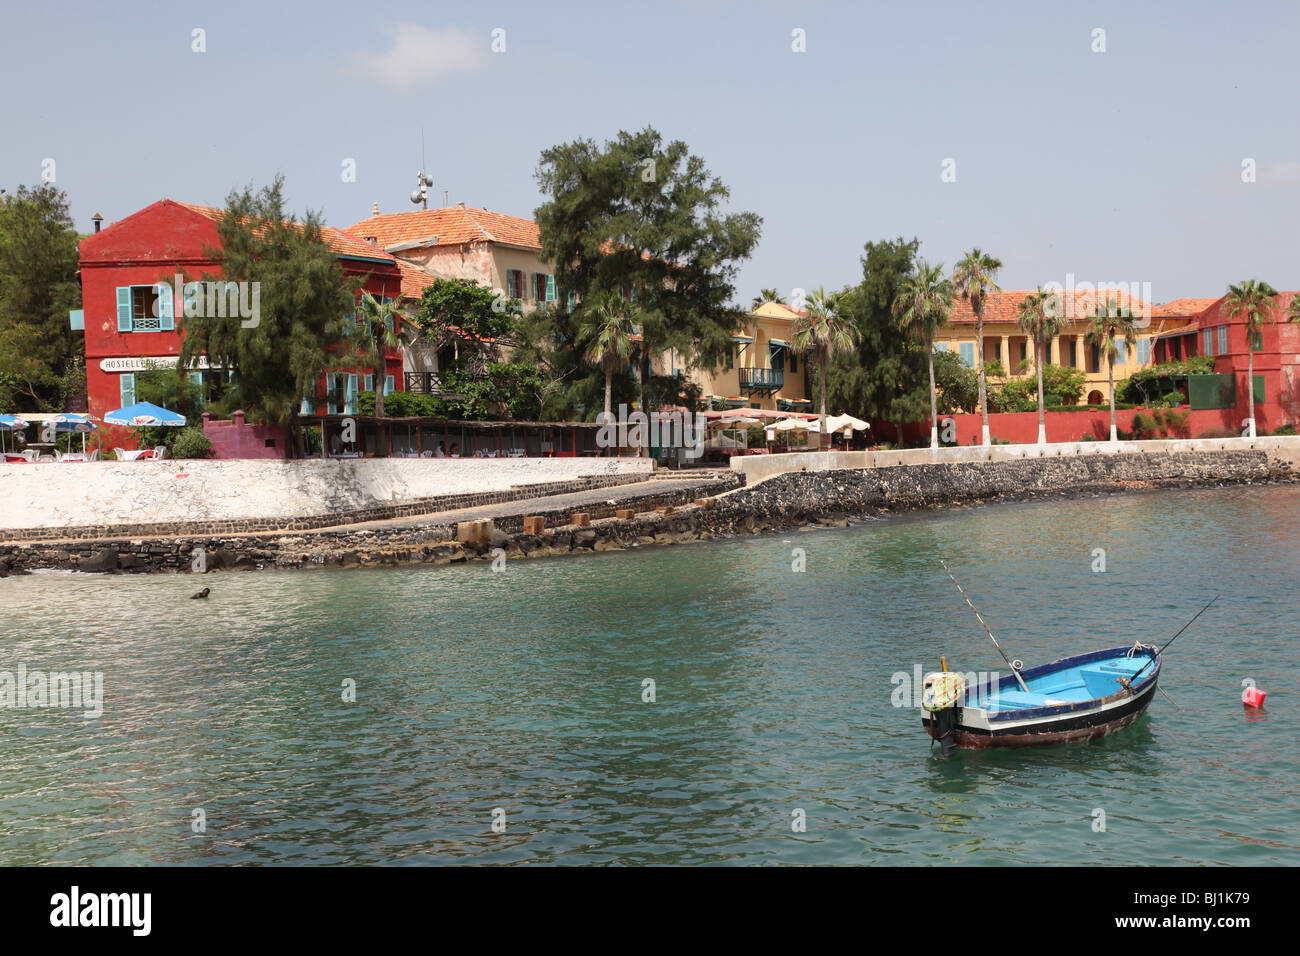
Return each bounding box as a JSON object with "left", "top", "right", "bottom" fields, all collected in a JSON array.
[{"left": 0, "top": 183, "right": 86, "bottom": 411}]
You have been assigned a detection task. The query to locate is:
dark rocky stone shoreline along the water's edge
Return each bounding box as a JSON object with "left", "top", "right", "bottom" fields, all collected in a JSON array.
[{"left": 0, "top": 451, "right": 1300, "bottom": 576}]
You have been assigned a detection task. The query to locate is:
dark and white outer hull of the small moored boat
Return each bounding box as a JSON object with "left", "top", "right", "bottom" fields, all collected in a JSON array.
[{"left": 922, "top": 649, "right": 1160, "bottom": 749}]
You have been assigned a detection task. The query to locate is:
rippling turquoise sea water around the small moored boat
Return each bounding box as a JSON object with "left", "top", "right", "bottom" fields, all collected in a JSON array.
[{"left": 0, "top": 486, "right": 1300, "bottom": 865}]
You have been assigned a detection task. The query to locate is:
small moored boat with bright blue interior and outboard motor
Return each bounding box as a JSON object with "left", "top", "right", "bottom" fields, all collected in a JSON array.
[{"left": 922, "top": 644, "right": 1160, "bottom": 753}]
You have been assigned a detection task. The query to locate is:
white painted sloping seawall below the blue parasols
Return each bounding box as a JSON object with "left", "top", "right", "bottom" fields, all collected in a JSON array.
[{"left": 0, "top": 458, "right": 653, "bottom": 528}]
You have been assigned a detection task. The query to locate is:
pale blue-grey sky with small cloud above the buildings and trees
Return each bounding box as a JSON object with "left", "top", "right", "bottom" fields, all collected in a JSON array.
[{"left": 0, "top": 0, "right": 1300, "bottom": 302}]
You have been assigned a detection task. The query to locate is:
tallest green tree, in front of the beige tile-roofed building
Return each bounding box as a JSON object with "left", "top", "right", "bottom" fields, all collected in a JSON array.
[{"left": 536, "top": 127, "right": 762, "bottom": 429}]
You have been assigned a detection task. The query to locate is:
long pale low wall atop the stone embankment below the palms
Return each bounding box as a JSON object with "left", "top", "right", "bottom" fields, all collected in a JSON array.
[{"left": 731, "top": 436, "right": 1300, "bottom": 485}]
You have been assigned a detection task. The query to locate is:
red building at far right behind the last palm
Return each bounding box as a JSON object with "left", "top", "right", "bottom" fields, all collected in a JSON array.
[{"left": 1154, "top": 293, "right": 1300, "bottom": 434}]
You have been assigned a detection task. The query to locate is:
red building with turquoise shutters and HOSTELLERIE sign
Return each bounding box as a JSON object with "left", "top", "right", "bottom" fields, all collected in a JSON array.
[{"left": 74, "top": 199, "right": 402, "bottom": 424}]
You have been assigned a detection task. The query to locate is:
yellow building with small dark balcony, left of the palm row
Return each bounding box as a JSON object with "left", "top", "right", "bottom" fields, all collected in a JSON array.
[{"left": 667, "top": 302, "right": 813, "bottom": 411}]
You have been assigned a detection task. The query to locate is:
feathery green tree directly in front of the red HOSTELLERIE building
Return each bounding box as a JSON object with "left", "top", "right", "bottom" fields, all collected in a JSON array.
[{"left": 177, "top": 177, "right": 359, "bottom": 423}]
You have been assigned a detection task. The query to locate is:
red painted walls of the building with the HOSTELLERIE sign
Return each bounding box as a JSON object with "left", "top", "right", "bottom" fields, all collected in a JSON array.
[{"left": 78, "top": 199, "right": 404, "bottom": 426}]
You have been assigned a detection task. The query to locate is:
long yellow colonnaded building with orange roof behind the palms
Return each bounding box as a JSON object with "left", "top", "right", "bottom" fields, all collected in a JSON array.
[{"left": 935, "top": 290, "right": 1188, "bottom": 405}]
